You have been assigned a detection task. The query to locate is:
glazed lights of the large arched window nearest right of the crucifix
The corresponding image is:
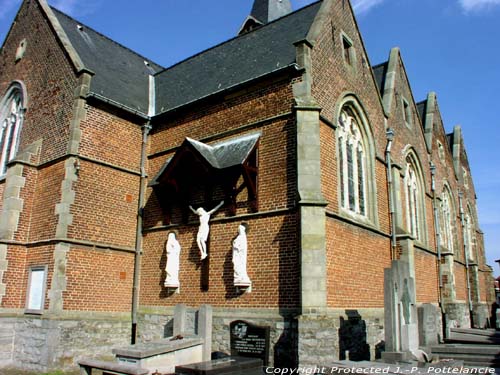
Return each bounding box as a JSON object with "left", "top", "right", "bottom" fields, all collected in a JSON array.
[{"left": 337, "top": 108, "right": 367, "bottom": 216}]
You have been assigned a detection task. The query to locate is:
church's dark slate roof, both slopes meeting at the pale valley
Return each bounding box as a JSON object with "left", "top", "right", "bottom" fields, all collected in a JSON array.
[{"left": 51, "top": 0, "right": 322, "bottom": 115}]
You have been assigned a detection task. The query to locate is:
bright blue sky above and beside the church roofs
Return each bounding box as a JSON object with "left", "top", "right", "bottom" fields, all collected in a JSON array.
[{"left": 0, "top": 0, "right": 500, "bottom": 276}]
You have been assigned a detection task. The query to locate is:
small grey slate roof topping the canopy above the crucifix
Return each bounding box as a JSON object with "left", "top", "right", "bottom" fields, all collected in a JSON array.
[{"left": 149, "top": 133, "right": 261, "bottom": 186}]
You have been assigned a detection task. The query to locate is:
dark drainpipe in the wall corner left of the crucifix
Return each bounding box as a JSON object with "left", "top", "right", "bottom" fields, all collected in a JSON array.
[{"left": 131, "top": 121, "right": 151, "bottom": 345}]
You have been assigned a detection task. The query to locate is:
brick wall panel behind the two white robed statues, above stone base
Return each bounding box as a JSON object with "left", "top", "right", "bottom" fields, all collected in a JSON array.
[{"left": 141, "top": 215, "right": 300, "bottom": 308}]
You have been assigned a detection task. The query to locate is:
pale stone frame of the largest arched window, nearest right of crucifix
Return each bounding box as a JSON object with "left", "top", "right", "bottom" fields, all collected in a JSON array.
[{"left": 335, "top": 94, "right": 378, "bottom": 227}]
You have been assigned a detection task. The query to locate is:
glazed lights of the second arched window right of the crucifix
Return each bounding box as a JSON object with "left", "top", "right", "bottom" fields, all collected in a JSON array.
[{"left": 404, "top": 154, "right": 424, "bottom": 240}]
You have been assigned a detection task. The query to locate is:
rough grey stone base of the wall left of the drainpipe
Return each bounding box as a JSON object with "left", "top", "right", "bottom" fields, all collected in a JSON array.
[{"left": 0, "top": 313, "right": 131, "bottom": 372}]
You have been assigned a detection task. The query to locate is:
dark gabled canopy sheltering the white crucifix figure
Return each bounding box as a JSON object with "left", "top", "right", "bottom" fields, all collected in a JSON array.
[{"left": 149, "top": 133, "right": 260, "bottom": 224}]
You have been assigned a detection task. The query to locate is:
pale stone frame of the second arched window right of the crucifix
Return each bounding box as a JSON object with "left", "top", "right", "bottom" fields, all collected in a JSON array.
[{"left": 403, "top": 149, "right": 428, "bottom": 244}]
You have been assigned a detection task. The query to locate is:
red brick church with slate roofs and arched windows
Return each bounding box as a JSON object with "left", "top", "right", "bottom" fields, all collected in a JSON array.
[{"left": 0, "top": 0, "right": 494, "bottom": 371}]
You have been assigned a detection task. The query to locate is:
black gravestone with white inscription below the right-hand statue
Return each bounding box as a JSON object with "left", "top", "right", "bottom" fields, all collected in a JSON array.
[{"left": 230, "top": 320, "right": 270, "bottom": 366}]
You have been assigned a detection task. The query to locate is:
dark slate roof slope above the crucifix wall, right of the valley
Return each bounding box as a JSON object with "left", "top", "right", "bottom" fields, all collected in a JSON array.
[{"left": 155, "top": 2, "right": 321, "bottom": 114}]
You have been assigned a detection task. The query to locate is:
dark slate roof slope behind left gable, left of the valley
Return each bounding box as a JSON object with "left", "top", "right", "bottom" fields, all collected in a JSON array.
[{"left": 52, "top": 8, "right": 163, "bottom": 114}]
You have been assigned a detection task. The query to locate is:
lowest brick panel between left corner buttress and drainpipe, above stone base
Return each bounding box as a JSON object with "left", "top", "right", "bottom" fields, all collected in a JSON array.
[{"left": 63, "top": 247, "right": 134, "bottom": 312}]
